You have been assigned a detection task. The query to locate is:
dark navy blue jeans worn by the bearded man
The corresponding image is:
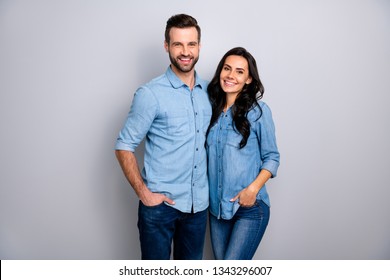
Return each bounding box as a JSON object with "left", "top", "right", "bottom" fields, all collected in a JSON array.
[{"left": 138, "top": 201, "right": 207, "bottom": 260}]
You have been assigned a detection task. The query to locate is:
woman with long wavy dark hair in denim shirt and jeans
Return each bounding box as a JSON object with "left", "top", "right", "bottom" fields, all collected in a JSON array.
[{"left": 207, "top": 47, "right": 279, "bottom": 260}]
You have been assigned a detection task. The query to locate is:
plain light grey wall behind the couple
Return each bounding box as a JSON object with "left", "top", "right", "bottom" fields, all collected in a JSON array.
[{"left": 0, "top": 0, "right": 390, "bottom": 259}]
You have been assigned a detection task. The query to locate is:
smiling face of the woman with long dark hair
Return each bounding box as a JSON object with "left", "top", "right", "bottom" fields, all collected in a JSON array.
[{"left": 219, "top": 55, "right": 252, "bottom": 96}]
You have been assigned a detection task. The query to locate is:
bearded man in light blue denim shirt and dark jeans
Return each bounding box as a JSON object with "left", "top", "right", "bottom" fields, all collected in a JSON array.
[{"left": 115, "top": 14, "right": 211, "bottom": 260}]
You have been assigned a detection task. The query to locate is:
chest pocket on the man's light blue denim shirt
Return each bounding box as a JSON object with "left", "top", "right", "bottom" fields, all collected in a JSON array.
[{"left": 164, "top": 109, "right": 191, "bottom": 135}]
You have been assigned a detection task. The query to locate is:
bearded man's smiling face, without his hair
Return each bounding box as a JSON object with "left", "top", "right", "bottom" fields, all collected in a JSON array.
[{"left": 164, "top": 27, "right": 200, "bottom": 73}]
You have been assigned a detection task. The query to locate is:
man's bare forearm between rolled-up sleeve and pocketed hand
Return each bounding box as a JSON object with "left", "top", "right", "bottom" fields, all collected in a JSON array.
[{"left": 115, "top": 150, "right": 150, "bottom": 200}]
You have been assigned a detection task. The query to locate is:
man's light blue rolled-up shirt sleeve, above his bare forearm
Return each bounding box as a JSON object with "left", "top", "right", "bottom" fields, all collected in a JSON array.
[{"left": 115, "top": 87, "right": 158, "bottom": 152}]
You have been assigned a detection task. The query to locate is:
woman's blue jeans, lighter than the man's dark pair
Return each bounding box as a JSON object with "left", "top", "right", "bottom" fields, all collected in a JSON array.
[{"left": 210, "top": 200, "right": 270, "bottom": 260}]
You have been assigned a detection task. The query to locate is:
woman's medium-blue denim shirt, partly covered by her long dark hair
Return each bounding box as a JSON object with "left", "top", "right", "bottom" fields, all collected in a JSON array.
[{"left": 207, "top": 101, "right": 280, "bottom": 220}]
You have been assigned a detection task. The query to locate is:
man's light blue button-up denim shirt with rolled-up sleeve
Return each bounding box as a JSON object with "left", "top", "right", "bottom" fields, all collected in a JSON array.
[{"left": 115, "top": 67, "right": 211, "bottom": 213}]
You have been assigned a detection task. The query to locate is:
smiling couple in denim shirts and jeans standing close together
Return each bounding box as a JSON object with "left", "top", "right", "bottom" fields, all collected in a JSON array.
[{"left": 115, "top": 14, "right": 279, "bottom": 260}]
